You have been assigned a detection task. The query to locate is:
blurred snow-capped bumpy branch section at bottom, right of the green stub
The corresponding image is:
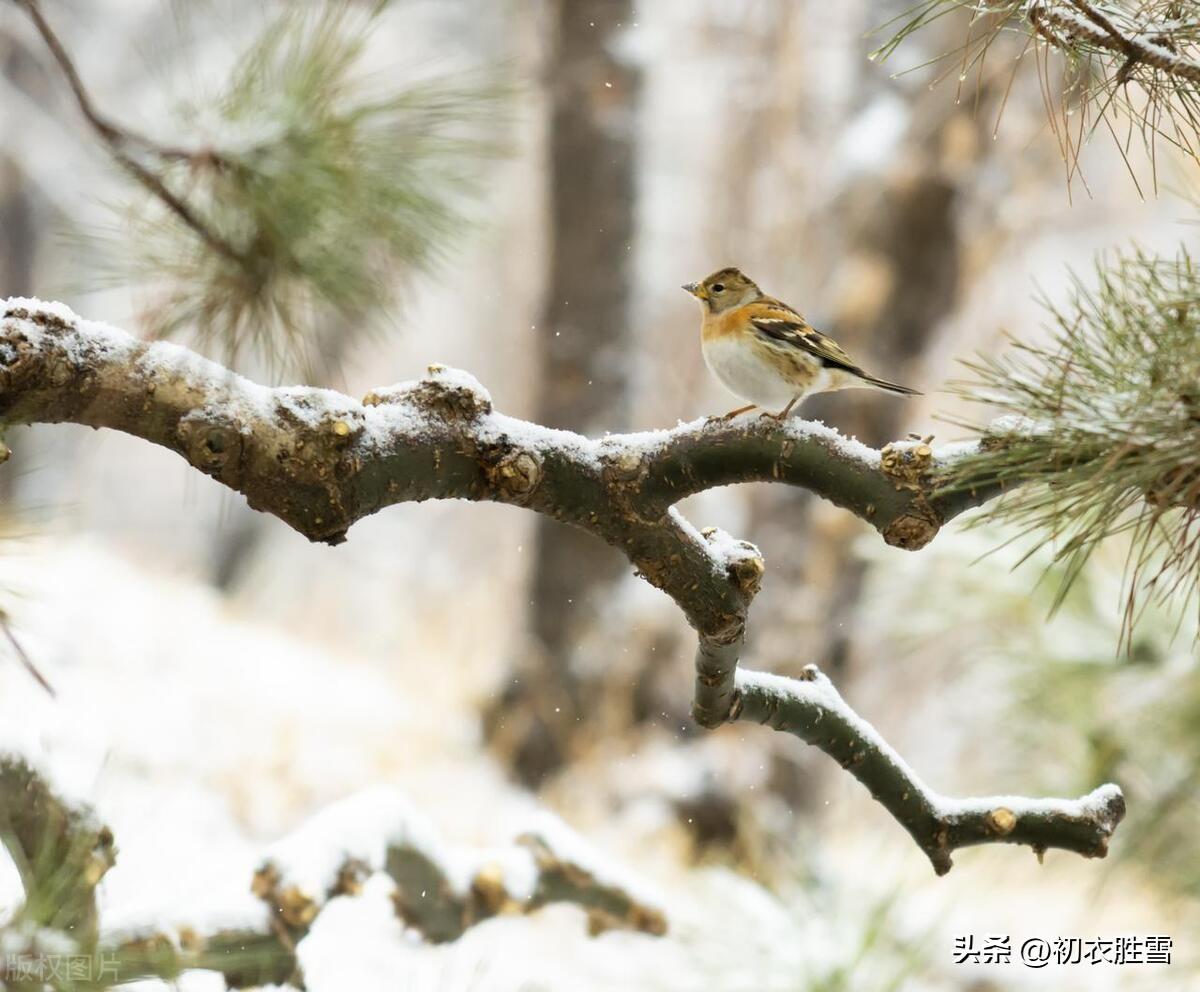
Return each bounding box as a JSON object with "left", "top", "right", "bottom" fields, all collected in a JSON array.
[{"left": 252, "top": 787, "right": 666, "bottom": 943}]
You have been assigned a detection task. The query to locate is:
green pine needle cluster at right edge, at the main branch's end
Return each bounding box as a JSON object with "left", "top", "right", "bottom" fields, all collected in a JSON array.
[{"left": 943, "top": 245, "right": 1200, "bottom": 636}]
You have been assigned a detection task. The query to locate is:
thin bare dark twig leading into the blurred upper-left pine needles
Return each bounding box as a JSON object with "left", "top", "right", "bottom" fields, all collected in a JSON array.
[{"left": 16, "top": 0, "right": 246, "bottom": 266}]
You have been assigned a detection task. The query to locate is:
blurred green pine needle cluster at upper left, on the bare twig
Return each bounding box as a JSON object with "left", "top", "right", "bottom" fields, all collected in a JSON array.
[{"left": 111, "top": 5, "right": 503, "bottom": 372}]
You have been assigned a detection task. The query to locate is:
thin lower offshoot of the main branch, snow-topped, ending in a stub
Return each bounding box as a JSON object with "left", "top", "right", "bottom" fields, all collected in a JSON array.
[{"left": 733, "top": 665, "right": 1126, "bottom": 874}]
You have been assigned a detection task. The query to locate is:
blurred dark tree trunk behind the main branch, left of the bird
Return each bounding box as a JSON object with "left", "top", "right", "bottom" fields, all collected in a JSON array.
[{"left": 486, "top": 0, "right": 640, "bottom": 786}]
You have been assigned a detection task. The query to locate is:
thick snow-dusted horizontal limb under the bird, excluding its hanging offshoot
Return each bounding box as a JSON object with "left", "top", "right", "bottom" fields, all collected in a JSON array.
[{"left": 0, "top": 299, "right": 970, "bottom": 551}]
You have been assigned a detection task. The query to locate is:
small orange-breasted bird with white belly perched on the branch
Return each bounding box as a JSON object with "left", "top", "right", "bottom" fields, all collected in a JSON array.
[{"left": 683, "top": 267, "right": 920, "bottom": 421}]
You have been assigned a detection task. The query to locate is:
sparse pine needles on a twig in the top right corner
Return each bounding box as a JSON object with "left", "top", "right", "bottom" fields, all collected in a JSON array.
[{"left": 871, "top": 0, "right": 1200, "bottom": 182}]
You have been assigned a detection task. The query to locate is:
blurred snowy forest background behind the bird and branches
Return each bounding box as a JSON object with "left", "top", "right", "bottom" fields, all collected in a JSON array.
[{"left": 0, "top": 0, "right": 1200, "bottom": 992}]
